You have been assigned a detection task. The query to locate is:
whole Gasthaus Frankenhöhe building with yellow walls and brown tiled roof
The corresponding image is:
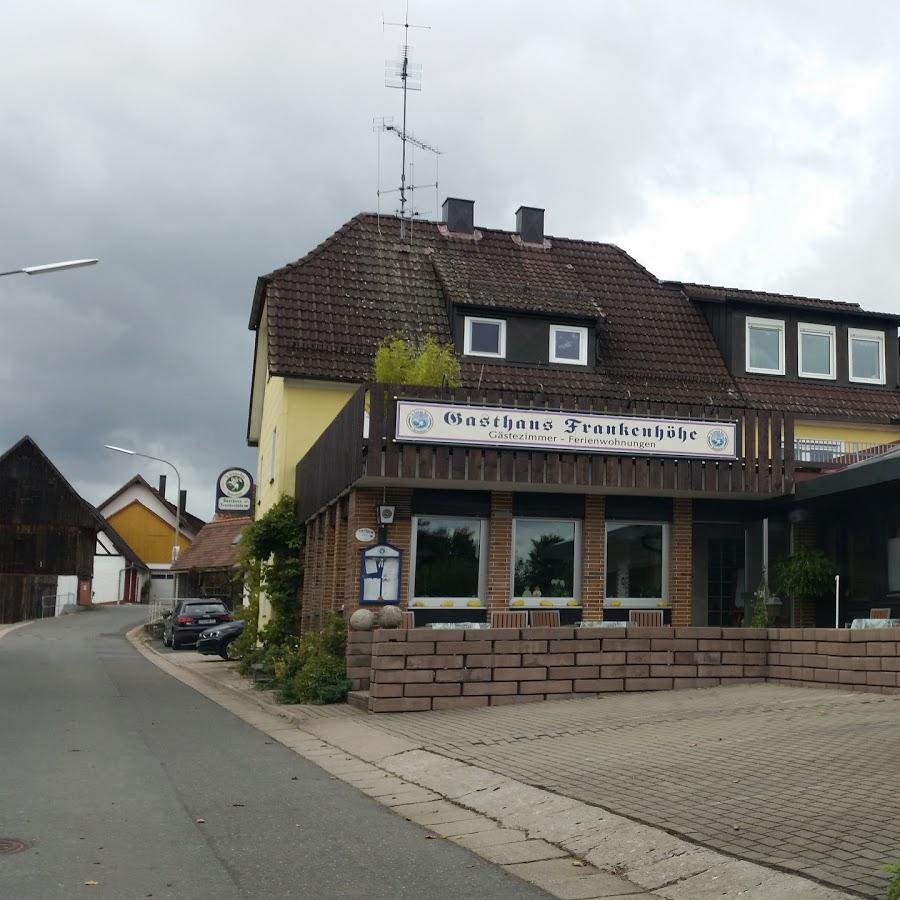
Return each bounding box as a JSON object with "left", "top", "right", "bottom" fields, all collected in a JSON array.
[{"left": 248, "top": 198, "right": 900, "bottom": 627}]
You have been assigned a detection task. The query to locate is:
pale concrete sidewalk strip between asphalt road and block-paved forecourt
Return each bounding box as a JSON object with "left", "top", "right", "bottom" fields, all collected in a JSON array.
[{"left": 130, "top": 632, "right": 872, "bottom": 900}]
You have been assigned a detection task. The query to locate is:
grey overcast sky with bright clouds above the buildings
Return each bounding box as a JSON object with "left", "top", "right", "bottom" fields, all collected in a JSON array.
[{"left": 0, "top": 0, "right": 900, "bottom": 518}]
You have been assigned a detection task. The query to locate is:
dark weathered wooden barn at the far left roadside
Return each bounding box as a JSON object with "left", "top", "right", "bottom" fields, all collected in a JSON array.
[{"left": 0, "top": 435, "right": 105, "bottom": 623}]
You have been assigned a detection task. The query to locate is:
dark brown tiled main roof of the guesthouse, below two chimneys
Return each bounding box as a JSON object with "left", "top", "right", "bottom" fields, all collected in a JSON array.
[{"left": 251, "top": 214, "right": 740, "bottom": 404}]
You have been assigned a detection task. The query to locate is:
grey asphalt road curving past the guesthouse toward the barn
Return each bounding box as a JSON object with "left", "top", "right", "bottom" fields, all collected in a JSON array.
[{"left": 0, "top": 607, "right": 547, "bottom": 900}]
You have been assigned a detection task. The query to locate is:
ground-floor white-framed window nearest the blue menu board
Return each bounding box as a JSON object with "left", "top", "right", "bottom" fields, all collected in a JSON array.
[{"left": 409, "top": 516, "right": 487, "bottom": 609}]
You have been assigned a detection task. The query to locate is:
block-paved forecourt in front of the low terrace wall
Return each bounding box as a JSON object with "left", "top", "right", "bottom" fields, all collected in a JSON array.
[{"left": 367, "top": 684, "right": 900, "bottom": 897}]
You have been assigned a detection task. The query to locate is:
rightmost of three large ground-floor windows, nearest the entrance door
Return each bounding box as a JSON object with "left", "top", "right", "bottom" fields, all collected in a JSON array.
[{"left": 603, "top": 521, "right": 669, "bottom": 609}]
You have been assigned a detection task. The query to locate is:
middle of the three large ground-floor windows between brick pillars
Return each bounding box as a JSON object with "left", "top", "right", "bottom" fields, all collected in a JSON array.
[{"left": 510, "top": 518, "right": 581, "bottom": 608}]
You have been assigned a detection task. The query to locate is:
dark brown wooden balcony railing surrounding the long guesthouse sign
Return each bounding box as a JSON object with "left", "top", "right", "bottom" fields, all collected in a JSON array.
[{"left": 296, "top": 385, "right": 794, "bottom": 520}]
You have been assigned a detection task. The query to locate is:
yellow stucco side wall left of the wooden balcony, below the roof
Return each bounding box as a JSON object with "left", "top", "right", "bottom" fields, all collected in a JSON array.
[{"left": 256, "top": 376, "right": 356, "bottom": 516}]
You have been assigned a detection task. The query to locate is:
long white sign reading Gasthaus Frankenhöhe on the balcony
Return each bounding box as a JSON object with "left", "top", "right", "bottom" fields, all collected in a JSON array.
[{"left": 397, "top": 400, "right": 737, "bottom": 459}]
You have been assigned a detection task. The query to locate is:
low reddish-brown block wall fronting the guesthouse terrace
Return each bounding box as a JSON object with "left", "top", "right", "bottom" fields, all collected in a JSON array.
[{"left": 362, "top": 627, "right": 900, "bottom": 712}]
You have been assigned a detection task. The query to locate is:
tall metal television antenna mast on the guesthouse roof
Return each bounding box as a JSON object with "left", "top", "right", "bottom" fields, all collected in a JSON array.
[{"left": 373, "top": 3, "right": 441, "bottom": 239}]
